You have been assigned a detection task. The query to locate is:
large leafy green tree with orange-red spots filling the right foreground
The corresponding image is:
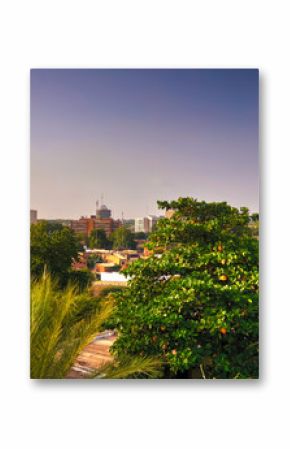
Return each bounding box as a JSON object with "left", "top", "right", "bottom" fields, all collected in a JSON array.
[{"left": 113, "top": 198, "right": 258, "bottom": 378}]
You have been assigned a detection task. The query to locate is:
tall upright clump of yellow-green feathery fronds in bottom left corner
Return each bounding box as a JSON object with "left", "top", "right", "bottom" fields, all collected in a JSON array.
[{"left": 30, "top": 275, "right": 112, "bottom": 379}]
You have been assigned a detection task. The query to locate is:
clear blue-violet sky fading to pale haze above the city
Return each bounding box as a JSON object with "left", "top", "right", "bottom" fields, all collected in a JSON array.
[{"left": 30, "top": 69, "right": 259, "bottom": 219}]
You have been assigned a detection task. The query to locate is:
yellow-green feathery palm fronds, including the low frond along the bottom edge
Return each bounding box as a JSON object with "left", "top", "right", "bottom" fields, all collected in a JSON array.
[{"left": 30, "top": 275, "right": 160, "bottom": 379}]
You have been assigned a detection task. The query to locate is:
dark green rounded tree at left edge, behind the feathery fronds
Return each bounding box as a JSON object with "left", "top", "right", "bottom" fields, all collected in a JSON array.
[{"left": 30, "top": 221, "right": 79, "bottom": 279}]
